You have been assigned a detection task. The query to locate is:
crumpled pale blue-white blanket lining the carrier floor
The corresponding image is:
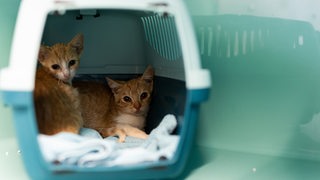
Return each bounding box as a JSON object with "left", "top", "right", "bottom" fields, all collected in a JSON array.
[{"left": 38, "top": 115, "right": 179, "bottom": 167}]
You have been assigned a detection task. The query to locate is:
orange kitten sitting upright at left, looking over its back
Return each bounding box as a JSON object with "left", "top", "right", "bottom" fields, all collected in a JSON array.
[{"left": 34, "top": 34, "right": 83, "bottom": 135}]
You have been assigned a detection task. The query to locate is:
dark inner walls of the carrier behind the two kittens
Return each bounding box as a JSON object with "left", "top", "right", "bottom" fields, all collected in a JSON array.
[{"left": 42, "top": 9, "right": 186, "bottom": 133}]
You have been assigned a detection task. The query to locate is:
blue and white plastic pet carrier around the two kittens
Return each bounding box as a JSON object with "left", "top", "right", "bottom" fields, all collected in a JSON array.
[{"left": 0, "top": 0, "right": 211, "bottom": 179}]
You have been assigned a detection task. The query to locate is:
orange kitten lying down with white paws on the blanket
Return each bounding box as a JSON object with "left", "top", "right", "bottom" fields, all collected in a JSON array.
[{"left": 74, "top": 66, "right": 154, "bottom": 142}]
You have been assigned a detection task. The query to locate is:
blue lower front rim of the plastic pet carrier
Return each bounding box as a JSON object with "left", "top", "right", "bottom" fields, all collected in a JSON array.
[{"left": 2, "top": 88, "right": 209, "bottom": 179}]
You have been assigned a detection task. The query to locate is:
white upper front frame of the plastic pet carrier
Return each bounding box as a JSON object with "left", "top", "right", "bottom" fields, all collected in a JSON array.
[{"left": 0, "top": 0, "right": 211, "bottom": 92}]
